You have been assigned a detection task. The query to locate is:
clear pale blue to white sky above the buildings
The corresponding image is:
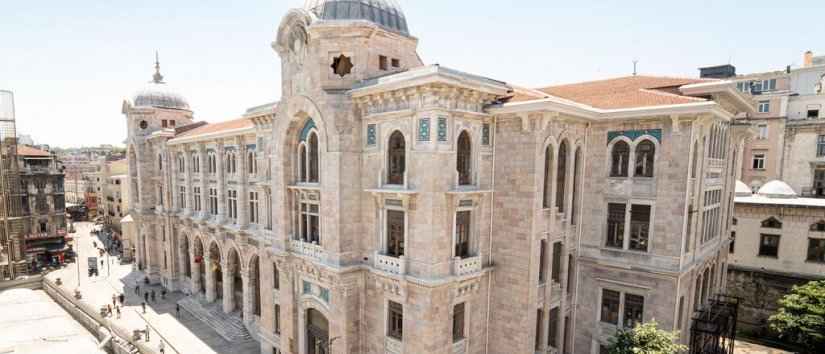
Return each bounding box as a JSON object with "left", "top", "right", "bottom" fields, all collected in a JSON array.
[{"left": 0, "top": 0, "right": 825, "bottom": 147}]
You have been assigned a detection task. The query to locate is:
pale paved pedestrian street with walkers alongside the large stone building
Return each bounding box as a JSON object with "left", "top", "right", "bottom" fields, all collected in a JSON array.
[{"left": 46, "top": 223, "right": 260, "bottom": 354}]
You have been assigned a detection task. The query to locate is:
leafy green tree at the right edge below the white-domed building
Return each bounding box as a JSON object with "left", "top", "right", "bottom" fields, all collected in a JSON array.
[{"left": 769, "top": 280, "right": 825, "bottom": 353}]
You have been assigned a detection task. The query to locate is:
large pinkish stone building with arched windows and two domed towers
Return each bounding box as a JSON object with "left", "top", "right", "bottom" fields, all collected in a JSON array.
[{"left": 123, "top": 0, "right": 754, "bottom": 354}]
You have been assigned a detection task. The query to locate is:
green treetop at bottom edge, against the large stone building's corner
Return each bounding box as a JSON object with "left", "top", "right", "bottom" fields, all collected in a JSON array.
[{"left": 607, "top": 321, "right": 687, "bottom": 354}]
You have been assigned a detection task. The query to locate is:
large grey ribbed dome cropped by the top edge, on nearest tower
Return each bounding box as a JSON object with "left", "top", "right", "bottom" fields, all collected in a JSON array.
[{"left": 304, "top": 0, "right": 410, "bottom": 35}]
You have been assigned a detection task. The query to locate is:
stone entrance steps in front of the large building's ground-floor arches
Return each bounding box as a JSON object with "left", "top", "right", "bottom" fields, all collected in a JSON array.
[{"left": 178, "top": 296, "right": 252, "bottom": 342}]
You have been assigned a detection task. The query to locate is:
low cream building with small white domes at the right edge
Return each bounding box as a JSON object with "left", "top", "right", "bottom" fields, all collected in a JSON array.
[{"left": 727, "top": 181, "right": 825, "bottom": 335}]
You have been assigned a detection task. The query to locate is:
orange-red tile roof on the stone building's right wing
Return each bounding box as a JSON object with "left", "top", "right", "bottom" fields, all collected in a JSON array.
[{"left": 509, "top": 76, "right": 713, "bottom": 109}]
